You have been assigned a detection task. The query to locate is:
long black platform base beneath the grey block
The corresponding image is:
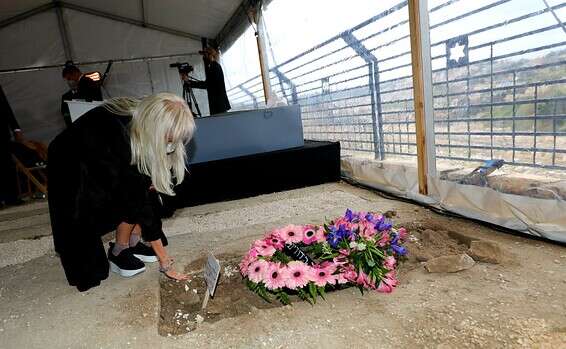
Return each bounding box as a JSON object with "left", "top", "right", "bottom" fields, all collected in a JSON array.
[{"left": 169, "top": 141, "right": 340, "bottom": 208}]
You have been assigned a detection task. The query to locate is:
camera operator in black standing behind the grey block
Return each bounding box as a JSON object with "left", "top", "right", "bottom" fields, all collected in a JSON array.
[{"left": 184, "top": 47, "right": 231, "bottom": 115}]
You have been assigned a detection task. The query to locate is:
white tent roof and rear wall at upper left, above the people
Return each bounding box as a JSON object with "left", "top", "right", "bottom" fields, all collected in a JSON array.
[{"left": 0, "top": 0, "right": 255, "bottom": 141}]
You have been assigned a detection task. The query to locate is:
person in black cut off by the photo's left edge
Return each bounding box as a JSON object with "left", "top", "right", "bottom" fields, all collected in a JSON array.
[{"left": 0, "top": 86, "right": 23, "bottom": 205}]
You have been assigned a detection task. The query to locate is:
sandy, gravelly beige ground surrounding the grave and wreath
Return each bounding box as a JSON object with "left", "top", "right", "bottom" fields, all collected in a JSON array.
[{"left": 0, "top": 184, "right": 566, "bottom": 348}]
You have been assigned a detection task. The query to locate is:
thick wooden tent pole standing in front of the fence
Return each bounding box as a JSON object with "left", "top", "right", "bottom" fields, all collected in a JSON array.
[{"left": 409, "top": 0, "right": 436, "bottom": 195}]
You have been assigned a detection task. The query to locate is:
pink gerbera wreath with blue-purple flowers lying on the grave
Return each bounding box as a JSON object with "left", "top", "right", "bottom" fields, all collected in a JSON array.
[{"left": 239, "top": 210, "right": 407, "bottom": 304}]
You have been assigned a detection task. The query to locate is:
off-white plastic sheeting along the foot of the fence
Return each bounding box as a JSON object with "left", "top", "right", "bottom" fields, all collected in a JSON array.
[{"left": 342, "top": 157, "right": 566, "bottom": 242}]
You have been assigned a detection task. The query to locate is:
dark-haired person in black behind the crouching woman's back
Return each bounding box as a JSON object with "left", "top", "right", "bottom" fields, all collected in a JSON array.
[{"left": 61, "top": 62, "right": 102, "bottom": 127}]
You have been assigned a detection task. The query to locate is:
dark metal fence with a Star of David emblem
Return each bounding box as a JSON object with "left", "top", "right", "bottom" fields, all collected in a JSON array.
[{"left": 229, "top": 0, "right": 566, "bottom": 169}]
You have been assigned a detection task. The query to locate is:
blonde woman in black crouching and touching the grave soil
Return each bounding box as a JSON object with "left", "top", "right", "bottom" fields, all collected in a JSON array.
[{"left": 48, "top": 93, "right": 195, "bottom": 291}]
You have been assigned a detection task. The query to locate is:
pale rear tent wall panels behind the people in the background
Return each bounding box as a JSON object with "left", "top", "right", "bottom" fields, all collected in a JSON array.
[{"left": 0, "top": 9, "right": 208, "bottom": 143}]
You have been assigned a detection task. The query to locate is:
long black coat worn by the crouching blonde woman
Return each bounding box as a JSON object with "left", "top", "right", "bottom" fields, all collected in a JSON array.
[{"left": 48, "top": 107, "right": 171, "bottom": 291}]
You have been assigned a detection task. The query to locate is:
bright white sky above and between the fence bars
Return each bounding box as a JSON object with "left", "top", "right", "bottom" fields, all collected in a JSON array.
[{"left": 222, "top": 0, "right": 566, "bottom": 96}]
